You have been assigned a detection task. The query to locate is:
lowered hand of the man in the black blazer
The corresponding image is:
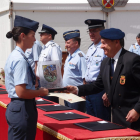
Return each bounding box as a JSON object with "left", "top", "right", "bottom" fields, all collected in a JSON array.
[{"left": 126, "top": 109, "right": 140, "bottom": 123}]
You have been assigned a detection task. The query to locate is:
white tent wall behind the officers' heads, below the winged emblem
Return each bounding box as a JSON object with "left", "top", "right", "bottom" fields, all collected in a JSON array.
[{"left": 16, "top": 10, "right": 140, "bottom": 53}]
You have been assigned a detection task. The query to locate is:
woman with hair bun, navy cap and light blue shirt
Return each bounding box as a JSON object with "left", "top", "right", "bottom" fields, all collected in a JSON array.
[{"left": 5, "top": 15, "right": 48, "bottom": 140}]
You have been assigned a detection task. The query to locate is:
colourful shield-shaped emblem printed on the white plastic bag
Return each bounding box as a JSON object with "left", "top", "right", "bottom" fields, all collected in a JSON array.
[{"left": 42, "top": 65, "right": 57, "bottom": 82}]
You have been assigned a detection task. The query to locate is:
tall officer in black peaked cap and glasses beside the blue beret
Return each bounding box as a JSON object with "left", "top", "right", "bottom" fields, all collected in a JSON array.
[{"left": 85, "top": 19, "right": 111, "bottom": 121}]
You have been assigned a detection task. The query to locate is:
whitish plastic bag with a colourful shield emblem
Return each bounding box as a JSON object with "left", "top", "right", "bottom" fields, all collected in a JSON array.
[{"left": 38, "top": 60, "right": 63, "bottom": 88}]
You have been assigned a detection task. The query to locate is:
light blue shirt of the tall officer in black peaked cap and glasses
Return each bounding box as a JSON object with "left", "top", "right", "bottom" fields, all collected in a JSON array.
[{"left": 85, "top": 42, "right": 106, "bottom": 82}]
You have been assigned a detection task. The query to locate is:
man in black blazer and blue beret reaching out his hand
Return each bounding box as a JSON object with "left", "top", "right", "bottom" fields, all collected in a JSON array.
[{"left": 67, "top": 28, "right": 140, "bottom": 131}]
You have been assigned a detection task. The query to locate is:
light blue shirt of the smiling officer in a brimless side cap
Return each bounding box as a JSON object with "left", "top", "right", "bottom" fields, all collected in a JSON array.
[{"left": 63, "top": 48, "right": 86, "bottom": 87}]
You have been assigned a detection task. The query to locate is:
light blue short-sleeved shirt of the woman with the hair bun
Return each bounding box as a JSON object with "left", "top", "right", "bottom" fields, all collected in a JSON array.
[{"left": 4, "top": 46, "right": 35, "bottom": 98}]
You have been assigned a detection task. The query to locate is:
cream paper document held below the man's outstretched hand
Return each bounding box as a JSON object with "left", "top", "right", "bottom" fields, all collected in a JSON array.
[{"left": 48, "top": 93, "right": 86, "bottom": 105}]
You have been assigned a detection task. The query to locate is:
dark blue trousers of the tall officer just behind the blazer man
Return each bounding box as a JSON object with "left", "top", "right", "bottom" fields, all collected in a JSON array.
[{"left": 86, "top": 91, "right": 111, "bottom": 121}]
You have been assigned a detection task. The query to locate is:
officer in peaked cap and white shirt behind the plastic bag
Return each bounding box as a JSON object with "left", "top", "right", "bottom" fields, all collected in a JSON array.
[{"left": 37, "top": 24, "right": 62, "bottom": 103}]
